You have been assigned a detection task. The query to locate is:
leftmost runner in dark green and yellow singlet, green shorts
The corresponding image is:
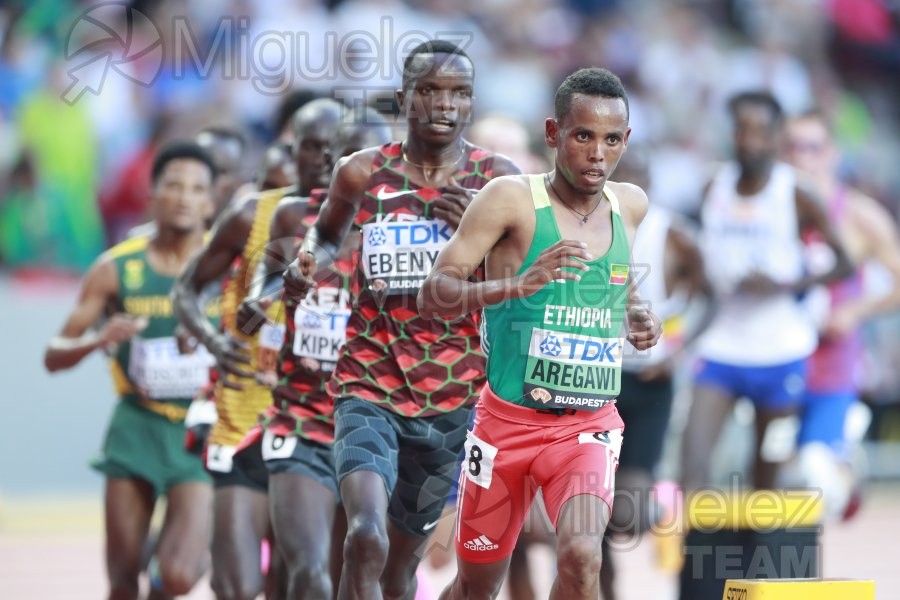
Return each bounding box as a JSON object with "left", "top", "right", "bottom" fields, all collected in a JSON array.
[{"left": 44, "top": 142, "right": 216, "bottom": 599}]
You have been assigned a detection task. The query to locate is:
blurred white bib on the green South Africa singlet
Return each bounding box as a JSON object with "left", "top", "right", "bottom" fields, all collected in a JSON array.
[{"left": 128, "top": 337, "right": 215, "bottom": 400}]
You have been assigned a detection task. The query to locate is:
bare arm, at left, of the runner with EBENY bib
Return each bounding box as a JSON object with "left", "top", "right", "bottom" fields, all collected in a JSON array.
[{"left": 284, "top": 148, "right": 379, "bottom": 299}]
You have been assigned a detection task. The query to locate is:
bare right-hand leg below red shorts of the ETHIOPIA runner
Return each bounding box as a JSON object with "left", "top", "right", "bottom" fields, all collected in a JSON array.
[{"left": 550, "top": 494, "right": 610, "bottom": 600}]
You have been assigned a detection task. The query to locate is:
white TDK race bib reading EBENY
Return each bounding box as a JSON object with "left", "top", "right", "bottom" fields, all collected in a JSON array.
[{"left": 362, "top": 215, "right": 453, "bottom": 294}]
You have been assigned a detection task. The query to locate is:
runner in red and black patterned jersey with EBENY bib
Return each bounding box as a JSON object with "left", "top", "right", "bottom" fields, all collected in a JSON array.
[{"left": 285, "top": 41, "right": 518, "bottom": 598}]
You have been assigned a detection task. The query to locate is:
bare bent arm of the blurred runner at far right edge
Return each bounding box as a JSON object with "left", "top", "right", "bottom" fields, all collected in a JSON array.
[{"left": 826, "top": 191, "right": 900, "bottom": 335}]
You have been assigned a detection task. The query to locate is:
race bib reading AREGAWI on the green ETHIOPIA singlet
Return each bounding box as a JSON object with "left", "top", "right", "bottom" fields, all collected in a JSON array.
[{"left": 523, "top": 327, "right": 625, "bottom": 411}]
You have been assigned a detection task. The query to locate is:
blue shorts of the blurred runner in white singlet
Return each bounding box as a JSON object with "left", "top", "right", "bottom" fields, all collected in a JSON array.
[{"left": 694, "top": 359, "right": 806, "bottom": 411}]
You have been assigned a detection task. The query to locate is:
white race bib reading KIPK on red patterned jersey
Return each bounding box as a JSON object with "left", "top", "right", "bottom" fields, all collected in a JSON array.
[{"left": 293, "top": 288, "right": 350, "bottom": 373}]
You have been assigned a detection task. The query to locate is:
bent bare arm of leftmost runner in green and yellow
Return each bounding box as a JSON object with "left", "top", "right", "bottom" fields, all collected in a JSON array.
[{"left": 44, "top": 256, "right": 147, "bottom": 372}]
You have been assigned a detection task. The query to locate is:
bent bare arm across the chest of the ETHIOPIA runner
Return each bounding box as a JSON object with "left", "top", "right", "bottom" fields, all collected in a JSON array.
[{"left": 417, "top": 175, "right": 590, "bottom": 319}]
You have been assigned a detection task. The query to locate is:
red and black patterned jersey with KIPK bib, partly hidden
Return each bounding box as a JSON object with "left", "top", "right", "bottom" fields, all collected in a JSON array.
[{"left": 264, "top": 190, "right": 358, "bottom": 444}]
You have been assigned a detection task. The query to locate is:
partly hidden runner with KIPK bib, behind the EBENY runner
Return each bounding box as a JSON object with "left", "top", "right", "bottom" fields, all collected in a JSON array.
[{"left": 238, "top": 108, "right": 391, "bottom": 598}]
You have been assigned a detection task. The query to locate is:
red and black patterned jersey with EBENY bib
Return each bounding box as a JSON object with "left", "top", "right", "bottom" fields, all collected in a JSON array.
[{"left": 328, "top": 142, "right": 494, "bottom": 417}]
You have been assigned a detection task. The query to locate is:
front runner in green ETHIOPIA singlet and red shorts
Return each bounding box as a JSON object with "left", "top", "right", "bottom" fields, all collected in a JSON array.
[{"left": 418, "top": 68, "right": 661, "bottom": 599}]
